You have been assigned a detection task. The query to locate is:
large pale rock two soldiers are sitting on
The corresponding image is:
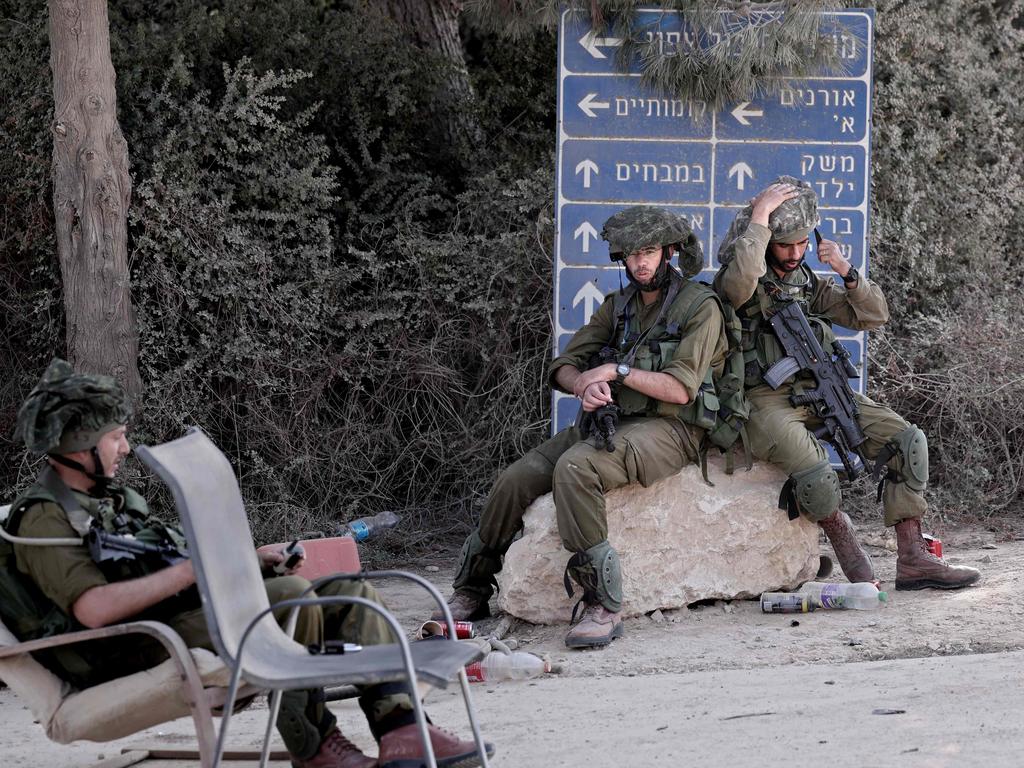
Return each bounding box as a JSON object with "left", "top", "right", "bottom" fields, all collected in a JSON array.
[{"left": 498, "top": 457, "right": 818, "bottom": 624}]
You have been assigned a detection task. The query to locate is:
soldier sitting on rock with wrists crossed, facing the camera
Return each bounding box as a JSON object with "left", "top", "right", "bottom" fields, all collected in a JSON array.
[{"left": 436, "top": 206, "right": 727, "bottom": 648}]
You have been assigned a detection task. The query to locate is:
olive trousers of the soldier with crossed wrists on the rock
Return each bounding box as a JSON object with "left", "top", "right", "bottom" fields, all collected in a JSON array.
[{"left": 478, "top": 417, "right": 698, "bottom": 565}]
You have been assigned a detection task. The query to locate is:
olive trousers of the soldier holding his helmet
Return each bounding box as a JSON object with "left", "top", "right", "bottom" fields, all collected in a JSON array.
[{"left": 746, "top": 385, "right": 928, "bottom": 525}]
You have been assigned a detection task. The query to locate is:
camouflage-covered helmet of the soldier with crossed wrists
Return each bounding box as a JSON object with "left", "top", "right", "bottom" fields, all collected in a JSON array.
[{"left": 601, "top": 206, "right": 703, "bottom": 278}]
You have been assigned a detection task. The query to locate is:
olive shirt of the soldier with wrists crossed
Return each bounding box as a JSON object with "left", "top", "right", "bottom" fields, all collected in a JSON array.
[{"left": 549, "top": 284, "right": 728, "bottom": 400}]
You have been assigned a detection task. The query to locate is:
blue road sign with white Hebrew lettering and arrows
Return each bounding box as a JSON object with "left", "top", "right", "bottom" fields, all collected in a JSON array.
[{"left": 552, "top": 10, "right": 874, "bottom": 438}]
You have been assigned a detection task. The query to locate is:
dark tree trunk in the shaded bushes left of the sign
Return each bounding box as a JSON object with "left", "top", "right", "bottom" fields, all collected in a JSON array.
[{"left": 385, "top": 0, "right": 483, "bottom": 163}]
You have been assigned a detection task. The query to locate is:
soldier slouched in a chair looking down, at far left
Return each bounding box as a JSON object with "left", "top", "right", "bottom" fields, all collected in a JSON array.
[{"left": 5, "top": 359, "right": 493, "bottom": 768}]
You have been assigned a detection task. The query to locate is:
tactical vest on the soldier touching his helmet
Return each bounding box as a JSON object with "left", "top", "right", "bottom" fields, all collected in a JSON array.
[{"left": 737, "top": 263, "right": 836, "bottom": 387}]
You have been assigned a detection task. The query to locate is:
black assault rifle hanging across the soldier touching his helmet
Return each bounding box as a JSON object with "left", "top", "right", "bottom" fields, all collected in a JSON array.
[{"left": 764, "top": 300, "right": 867, "bottom": 480}]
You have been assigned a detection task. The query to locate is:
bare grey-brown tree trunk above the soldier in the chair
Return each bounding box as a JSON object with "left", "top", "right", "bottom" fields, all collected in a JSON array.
[{"left": 48, "top": 0, "right": 142, "bottom": 398}]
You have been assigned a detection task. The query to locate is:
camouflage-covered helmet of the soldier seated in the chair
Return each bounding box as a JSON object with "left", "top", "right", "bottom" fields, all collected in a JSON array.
[{"left": 14, "top": 357, "right": 131, "bottom": 454}]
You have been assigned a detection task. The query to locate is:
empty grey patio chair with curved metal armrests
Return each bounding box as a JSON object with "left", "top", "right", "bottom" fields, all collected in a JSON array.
[{"left": 136, "top": 428, "right": 487, "bottom": 768}]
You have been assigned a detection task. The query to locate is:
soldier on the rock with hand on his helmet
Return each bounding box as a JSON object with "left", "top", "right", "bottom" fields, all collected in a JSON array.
[{"left": 715, "top": 176, "right": 981, "bottom": 590}]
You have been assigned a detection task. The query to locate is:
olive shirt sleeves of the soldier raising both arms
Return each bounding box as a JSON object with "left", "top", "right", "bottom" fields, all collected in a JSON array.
[{"left": 715, "top": 223, "right": 889, "bottom": 331}]
